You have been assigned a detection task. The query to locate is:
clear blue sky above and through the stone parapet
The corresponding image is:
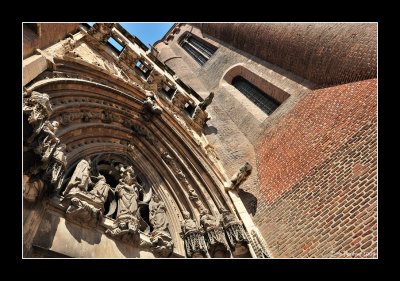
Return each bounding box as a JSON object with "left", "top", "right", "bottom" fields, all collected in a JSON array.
[{"left": 88, "top": 22, "right": 174, "bottom": 47}]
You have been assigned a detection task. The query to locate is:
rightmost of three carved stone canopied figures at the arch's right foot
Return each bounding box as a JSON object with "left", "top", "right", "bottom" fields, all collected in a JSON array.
[{"left": 222, "top": 210, "right": 249, "bottom": 256}]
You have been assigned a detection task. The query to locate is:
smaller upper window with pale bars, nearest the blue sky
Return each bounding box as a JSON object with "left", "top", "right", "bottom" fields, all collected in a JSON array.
[{"left": 180, "top": 33, "right": 216, "bottom": 65}]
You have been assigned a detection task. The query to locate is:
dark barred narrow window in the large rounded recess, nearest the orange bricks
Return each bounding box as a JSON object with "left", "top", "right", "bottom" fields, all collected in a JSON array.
[{"left": 232, "top": 76, "right": 280, "bottom": 115}]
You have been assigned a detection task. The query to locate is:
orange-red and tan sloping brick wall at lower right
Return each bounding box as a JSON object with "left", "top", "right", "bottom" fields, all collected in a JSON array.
[{"left": 254, "top": 79, "right": 377, "bottom": 257}]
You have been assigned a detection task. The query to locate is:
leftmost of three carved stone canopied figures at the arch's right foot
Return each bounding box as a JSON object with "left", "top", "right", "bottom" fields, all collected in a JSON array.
[{"left": 182, "top": 211, "right": 207, "bottom": 258}]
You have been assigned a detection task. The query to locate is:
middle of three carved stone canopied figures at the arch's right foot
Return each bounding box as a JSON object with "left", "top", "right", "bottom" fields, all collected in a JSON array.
[{"left": 200, "top": 210, "right": 230, "bottom": 258}]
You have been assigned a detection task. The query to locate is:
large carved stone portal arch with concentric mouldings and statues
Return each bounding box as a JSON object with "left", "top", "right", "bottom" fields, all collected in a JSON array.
[{"left": 23, "top": 24, "right": 260, "bottom": 257}]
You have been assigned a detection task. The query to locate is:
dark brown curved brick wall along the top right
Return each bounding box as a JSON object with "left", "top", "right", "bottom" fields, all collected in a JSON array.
[{"left": 192, "top": 23, "right": 377, "bottom": 86}]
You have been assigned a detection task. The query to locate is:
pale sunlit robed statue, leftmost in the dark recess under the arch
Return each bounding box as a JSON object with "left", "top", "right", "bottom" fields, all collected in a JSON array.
[{"left": 63, "top": 156, "right": 91, "bottom": 196}]
